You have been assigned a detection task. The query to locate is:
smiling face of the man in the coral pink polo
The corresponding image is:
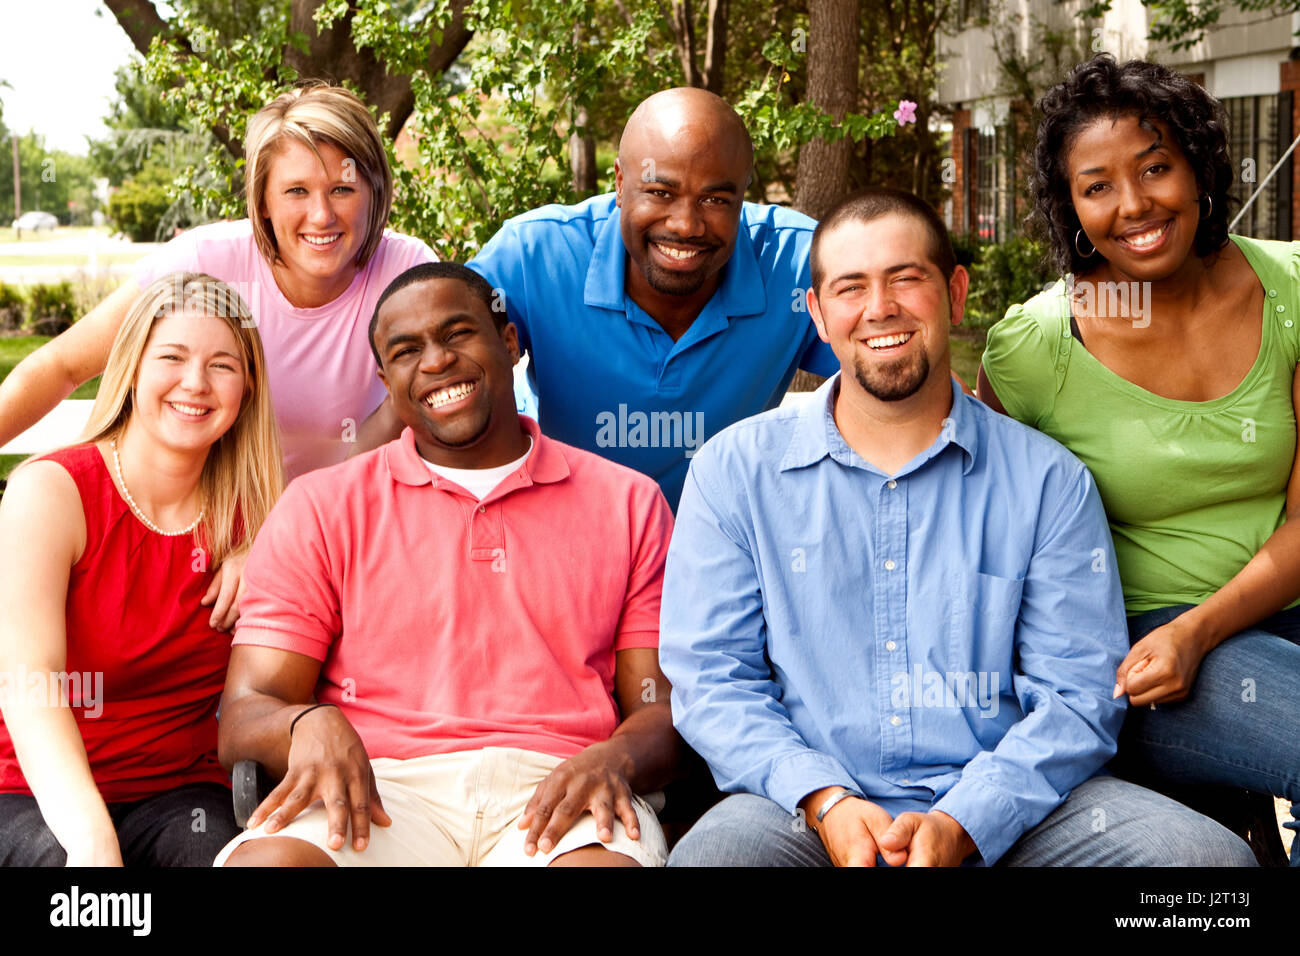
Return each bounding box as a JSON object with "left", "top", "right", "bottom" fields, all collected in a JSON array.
[{"left": 374, "top": 278, "right": 521, "bottom": 468}]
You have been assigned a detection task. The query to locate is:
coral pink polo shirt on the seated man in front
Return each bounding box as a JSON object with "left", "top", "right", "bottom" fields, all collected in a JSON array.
[{"left": 234, "top": 416, "right": 672, "bottom": 760}]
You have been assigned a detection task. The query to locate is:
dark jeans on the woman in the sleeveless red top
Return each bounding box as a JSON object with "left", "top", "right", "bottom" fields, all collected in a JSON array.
[{"left": 0, "top": 783, "right": 239, "bottom": 866}]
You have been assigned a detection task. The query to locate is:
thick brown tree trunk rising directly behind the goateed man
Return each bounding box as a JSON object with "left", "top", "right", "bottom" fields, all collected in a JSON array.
[{"left": 794, "top": 0, "right": 858, "bottom": 219}]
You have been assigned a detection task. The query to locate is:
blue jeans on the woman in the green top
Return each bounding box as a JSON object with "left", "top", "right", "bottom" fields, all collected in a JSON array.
[{"left": 1114, "top": 605, "right": 1300, "bottom": 866}]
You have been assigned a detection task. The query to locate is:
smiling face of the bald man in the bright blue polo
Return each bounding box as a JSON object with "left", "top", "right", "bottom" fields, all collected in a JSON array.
[{"left": 615, "top": 109, "right": 751, "bottom": 297}]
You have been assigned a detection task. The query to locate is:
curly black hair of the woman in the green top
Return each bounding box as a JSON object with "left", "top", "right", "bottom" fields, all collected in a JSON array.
[{"left": 1031, "top": 53, "right": 1232, "bottom": 273}]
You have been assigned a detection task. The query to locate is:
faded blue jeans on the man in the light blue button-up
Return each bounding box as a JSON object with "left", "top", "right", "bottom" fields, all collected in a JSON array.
[{"left": 668, "top": 775, "right": 1256, "bottom": 866}]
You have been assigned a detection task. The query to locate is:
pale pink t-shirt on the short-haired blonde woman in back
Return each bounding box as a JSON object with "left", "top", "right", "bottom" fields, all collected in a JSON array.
[{"left": 135, "top": 219, "right": 437, "bottom": 479}]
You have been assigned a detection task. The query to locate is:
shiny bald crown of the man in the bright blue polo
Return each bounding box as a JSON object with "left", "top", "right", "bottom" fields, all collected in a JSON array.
[{"left": 619, "top": 86, "right": 754, "bottom": 186}]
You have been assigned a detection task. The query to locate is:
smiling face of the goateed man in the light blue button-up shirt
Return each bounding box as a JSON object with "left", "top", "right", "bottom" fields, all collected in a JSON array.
[{"left": 807, "top": 213, "right": 967, "bottom": 402}]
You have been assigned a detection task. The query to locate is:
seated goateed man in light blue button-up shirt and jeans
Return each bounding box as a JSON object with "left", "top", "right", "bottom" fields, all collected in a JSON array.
[{"left": 660, "top": 190, "right": 1253, "bottom": 865}]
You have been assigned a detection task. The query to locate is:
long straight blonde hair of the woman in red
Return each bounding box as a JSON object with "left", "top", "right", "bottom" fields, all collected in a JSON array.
[{"left": 77, "top": 272, "right": 285, "bottom": 567}]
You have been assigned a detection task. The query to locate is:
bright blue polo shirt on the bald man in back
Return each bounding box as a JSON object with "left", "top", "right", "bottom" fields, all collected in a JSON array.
[{"left": 469, "top": 193, "right": 840, "bottom": 510}]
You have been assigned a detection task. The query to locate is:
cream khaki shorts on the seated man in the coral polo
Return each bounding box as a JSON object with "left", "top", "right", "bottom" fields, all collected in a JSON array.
[{"left": 213, "top": 747, "right": 668, "bottom": 866}]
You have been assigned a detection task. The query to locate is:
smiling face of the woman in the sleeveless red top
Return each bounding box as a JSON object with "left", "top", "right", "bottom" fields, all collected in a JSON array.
[{"left": 133, "top": 311, "right": 248, "bottom": 451}]
